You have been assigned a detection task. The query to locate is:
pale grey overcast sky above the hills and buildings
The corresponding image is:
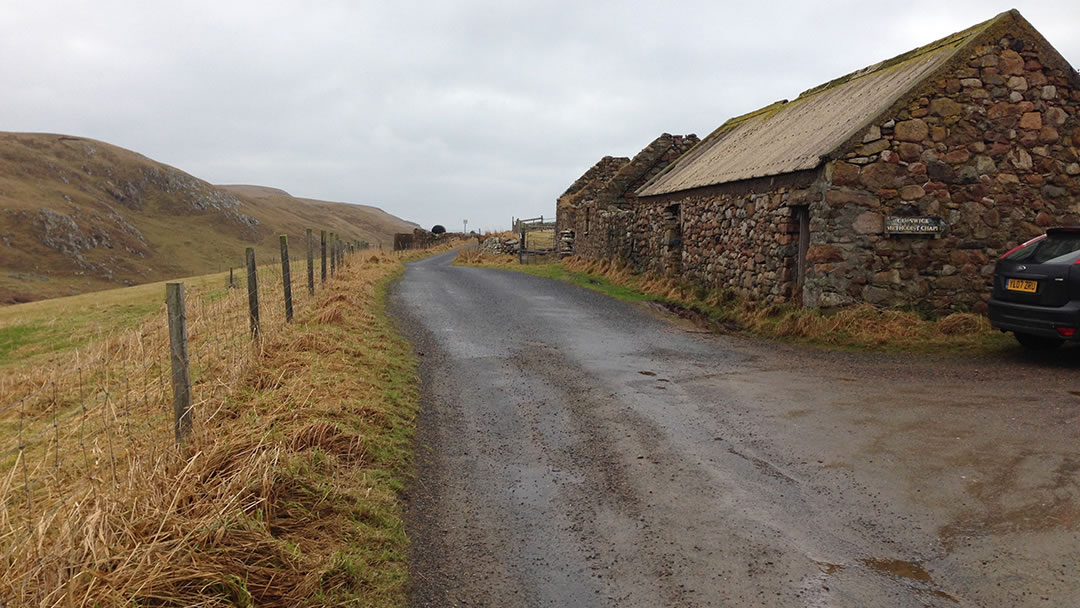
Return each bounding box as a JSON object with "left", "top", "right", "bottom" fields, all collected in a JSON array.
[{"left": 0, "top": 0, "right": 1080, "bottom": 229}]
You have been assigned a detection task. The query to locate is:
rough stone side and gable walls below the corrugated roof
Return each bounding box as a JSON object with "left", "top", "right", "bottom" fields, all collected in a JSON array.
[{"left": 559, "top": 28, "right": 1080, "bottom": 314}]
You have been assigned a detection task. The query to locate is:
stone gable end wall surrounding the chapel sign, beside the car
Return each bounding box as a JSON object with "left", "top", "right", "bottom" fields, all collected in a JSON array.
[{"left": 804, "top": 30, "right": 1080, "bottom": 313}]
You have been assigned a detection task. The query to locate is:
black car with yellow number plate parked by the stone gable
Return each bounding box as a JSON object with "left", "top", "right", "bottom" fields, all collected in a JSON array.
[{"left": 989, "top": 227, "right": 1080, "bottom": 350}]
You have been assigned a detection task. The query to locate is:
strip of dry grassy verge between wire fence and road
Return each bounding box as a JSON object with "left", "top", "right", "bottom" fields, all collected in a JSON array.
[{"left": 0, "top": 247, "right": 466, "bottom": 607}]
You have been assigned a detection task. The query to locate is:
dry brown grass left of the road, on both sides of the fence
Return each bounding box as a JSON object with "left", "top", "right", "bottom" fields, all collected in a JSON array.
[{"left": 0, "top": 242, "right": 464, "bottom": 606}]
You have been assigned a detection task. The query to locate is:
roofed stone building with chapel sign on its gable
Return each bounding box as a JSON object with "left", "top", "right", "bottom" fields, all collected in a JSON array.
[{"left": 577, "top": 11, "right": 1080, "bottom": 312}]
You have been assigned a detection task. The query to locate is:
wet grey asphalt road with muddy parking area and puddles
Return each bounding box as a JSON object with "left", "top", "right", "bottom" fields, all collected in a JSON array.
[{"left": 391, "top": 249, "right": 1080, "bottom": 607}]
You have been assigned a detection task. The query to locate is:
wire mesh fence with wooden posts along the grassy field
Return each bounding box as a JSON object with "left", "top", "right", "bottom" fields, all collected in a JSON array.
[{"left": 0, "top": 233, "right": 363, "bottom": 607}]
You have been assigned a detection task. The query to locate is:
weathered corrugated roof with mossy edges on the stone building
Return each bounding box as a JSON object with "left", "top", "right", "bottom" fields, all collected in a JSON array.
[{"left": 638, "top": 13, "right": 1009, "bottom": 197}]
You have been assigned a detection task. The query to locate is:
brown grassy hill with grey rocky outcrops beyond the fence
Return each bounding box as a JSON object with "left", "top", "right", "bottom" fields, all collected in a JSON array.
[{"left": 0, "top": 133, "right": 417, "bottom": 303}]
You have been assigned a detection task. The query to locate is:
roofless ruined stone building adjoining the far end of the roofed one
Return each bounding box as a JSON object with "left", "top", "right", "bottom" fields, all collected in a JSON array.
[{"left": 555, "top": 133, "right": 699, "bottom": 257}]
